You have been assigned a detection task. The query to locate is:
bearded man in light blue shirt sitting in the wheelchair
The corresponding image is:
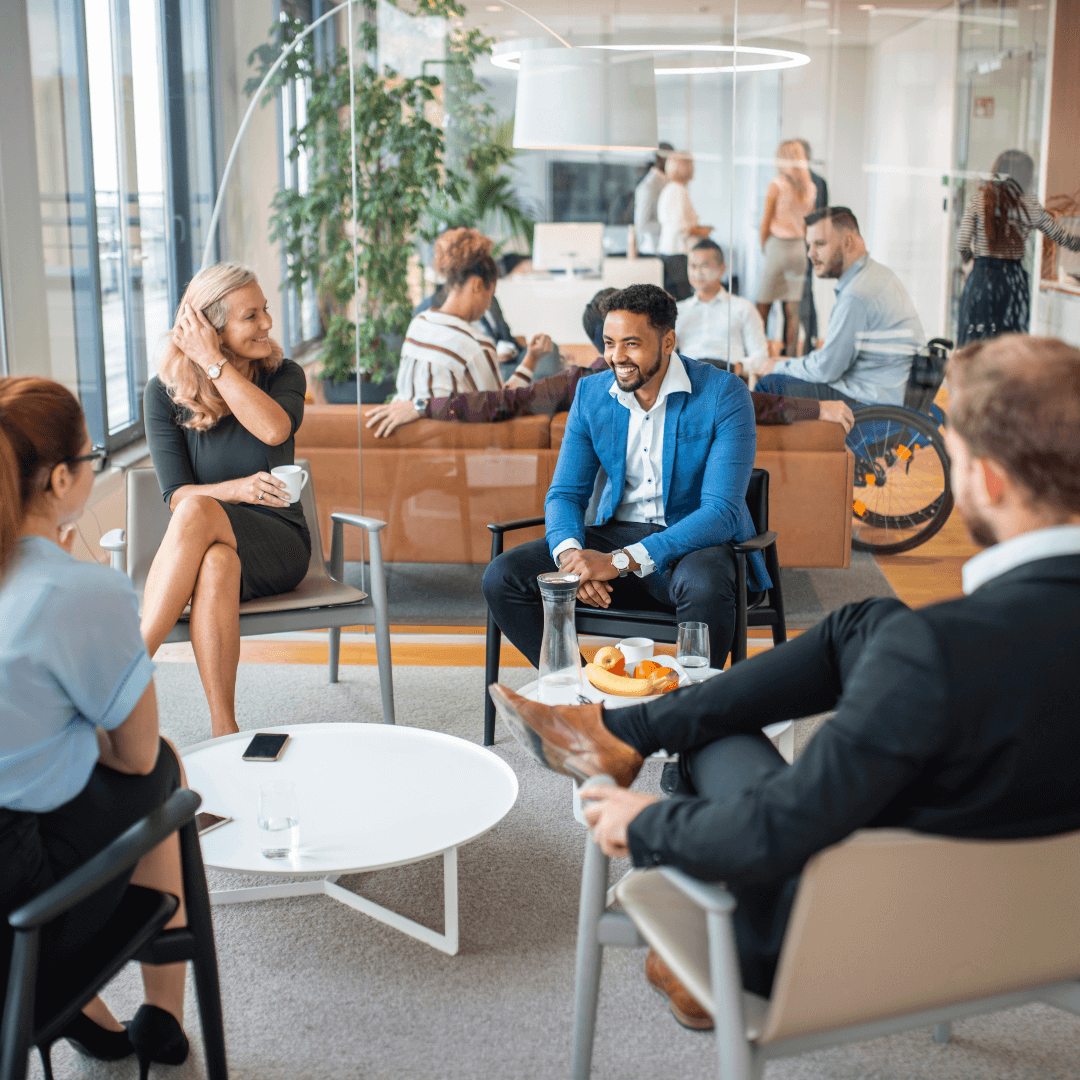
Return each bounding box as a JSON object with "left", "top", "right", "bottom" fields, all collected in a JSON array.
[{"left": 756, "top": 206, "right": 927, "bottom": 407}]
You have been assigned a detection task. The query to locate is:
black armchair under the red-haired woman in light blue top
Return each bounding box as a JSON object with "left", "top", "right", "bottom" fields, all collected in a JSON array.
[{"left": 0, "top": 788, "right": 228, "bottom": 1080}]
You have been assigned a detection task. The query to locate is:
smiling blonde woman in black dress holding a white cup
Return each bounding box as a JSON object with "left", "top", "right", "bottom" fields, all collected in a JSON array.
[{"left": 143, "top": 262, "right": 311, "bottom": 737}]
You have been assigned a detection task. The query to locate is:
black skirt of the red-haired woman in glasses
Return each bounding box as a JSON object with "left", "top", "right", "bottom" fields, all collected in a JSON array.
[{"left": 0, "top": 740, "right": 180, "bottom": 981}]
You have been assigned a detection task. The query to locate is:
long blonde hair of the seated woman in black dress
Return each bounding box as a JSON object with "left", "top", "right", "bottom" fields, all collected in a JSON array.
[{"left": 158, "top": 262, "right": 285, "bottom": 431}]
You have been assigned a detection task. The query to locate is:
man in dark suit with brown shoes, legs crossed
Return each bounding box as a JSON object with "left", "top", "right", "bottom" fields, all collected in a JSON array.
[{"left": 491, "top": 335, "right": 1080, "bottom": 1026}]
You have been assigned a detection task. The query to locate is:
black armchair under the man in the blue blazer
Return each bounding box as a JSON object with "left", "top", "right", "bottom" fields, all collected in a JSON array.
[{"left": 484, "top": 469, "right": 787, "bottom": 746}]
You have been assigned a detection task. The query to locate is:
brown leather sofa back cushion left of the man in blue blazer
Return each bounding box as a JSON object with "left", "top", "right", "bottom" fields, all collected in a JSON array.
[{"left": 296, "top": 405, "right": 551, "bottom": 450}]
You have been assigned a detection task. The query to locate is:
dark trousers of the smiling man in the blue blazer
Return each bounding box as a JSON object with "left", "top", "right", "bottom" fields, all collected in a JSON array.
[{"left": 483, "top": 522, "right": 735, "bottom": 667}]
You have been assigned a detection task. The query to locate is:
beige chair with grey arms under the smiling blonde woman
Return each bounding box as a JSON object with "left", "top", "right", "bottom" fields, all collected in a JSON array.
[{"left": 102, "top": 458, "right": 394, "bottom": 724}]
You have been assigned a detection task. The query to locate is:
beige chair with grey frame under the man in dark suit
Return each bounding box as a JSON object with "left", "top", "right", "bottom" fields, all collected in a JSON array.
[{"left": 573, "top": 778, "right": 1080, "bottom": 1080}]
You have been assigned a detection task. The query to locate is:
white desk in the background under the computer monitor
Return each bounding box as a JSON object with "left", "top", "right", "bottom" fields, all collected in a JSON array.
[{"left": 495, "top": 258, "right": 664, "bottom": 345}]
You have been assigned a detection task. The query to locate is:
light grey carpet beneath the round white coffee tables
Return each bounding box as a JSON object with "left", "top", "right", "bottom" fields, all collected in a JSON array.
[{"left": 30, "top": 663, "right": 1080, "bottom": 1080}]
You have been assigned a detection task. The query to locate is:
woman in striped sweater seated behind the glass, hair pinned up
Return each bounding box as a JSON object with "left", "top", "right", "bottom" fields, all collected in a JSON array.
[{"left": 394, "top": 229, "right": 553, "bottom": 402}]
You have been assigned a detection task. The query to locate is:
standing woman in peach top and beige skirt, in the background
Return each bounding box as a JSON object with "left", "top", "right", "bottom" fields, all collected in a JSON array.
[{"left": 757, "top": 139, "right": 816, "bottom": 356}]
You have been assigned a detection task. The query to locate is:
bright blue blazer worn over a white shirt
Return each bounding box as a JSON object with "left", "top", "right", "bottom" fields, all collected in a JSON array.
[{"left": 544, "top": 356, "right": 772, "bottom": 590}]
